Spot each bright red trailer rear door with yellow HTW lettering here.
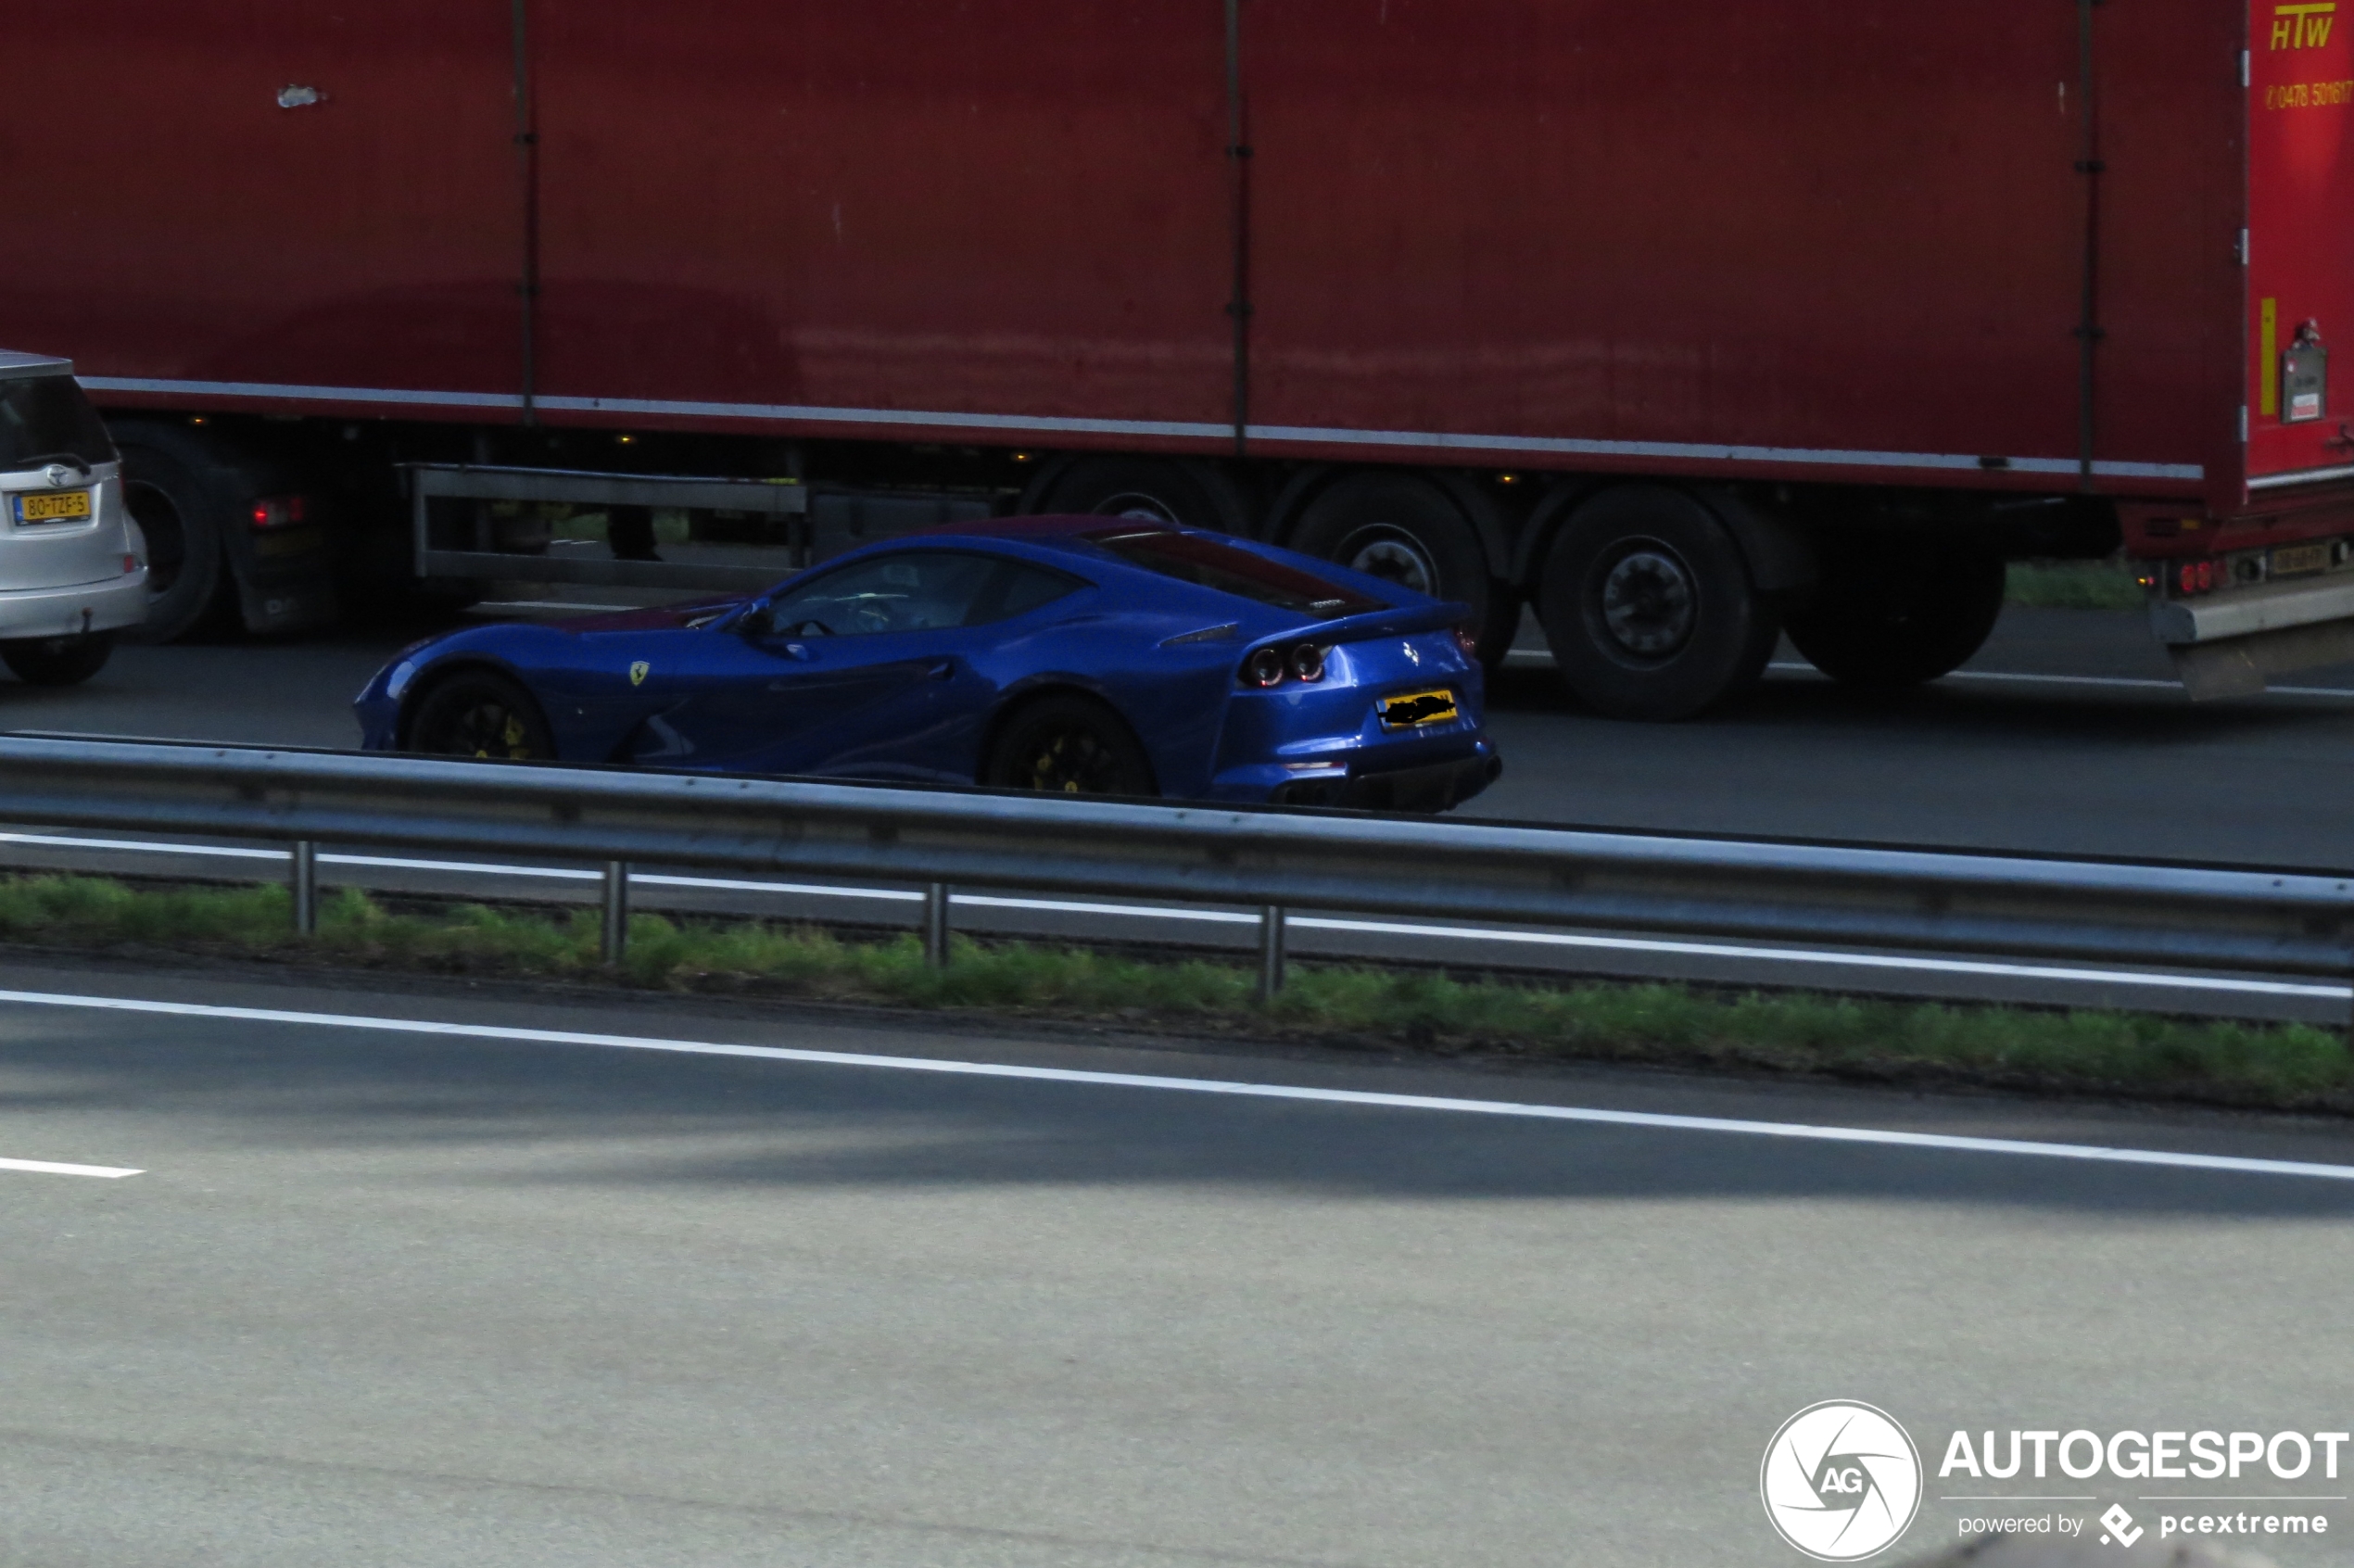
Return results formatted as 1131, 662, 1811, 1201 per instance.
2248, 0, 2354, 492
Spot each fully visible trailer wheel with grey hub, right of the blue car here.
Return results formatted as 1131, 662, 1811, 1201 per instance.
1538, 485, 1779, 720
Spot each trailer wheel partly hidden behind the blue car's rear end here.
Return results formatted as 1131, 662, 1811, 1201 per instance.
1290, 471, 1521, 664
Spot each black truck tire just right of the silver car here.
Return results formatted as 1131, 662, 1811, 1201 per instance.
115, 424, 243, 643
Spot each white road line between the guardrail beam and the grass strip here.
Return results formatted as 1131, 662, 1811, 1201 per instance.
0, 833, 2354, 1001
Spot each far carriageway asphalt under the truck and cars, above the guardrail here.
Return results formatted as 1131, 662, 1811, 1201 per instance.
0, 600, 2354, 868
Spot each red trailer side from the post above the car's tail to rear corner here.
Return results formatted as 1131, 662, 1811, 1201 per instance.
1246, 0, 2236, 489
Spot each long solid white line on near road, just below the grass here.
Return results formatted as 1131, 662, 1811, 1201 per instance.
0, 992, 2354, 1182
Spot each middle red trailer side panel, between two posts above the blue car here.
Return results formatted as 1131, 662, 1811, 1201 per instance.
535, 0, 1231, 445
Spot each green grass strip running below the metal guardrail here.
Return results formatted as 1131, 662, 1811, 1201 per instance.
0, 876, 2354, 1111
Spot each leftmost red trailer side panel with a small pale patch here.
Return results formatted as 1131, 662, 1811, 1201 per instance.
0, 0, 523, 417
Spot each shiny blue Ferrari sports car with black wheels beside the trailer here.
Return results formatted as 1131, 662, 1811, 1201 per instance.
356, 518, 1502, 810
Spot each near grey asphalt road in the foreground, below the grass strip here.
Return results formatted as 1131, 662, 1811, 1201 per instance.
0, 967, 2354, 1568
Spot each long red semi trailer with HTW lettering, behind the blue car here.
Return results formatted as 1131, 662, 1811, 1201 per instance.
0, 0, 2354, 718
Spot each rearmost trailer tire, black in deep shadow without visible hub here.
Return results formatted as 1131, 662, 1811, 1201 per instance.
1784, 541, 2006, 692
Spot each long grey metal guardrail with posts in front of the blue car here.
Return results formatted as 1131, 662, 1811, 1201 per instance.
0, 737, 2354, 1007
